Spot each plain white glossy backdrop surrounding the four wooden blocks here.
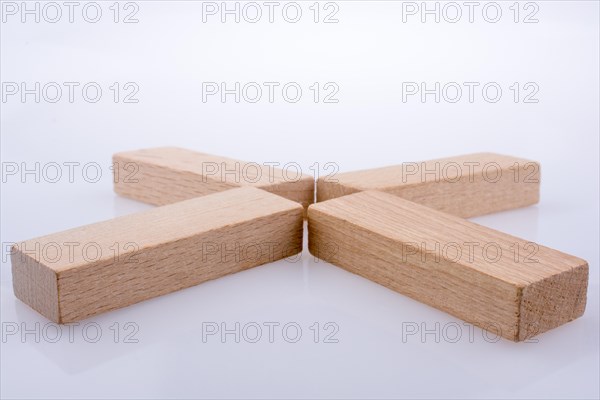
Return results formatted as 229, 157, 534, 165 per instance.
0, 1, 600, 398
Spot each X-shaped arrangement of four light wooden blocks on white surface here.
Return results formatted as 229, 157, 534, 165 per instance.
11, 147, 588, 341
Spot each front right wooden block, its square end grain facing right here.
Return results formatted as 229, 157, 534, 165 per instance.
308, 191, 588, 341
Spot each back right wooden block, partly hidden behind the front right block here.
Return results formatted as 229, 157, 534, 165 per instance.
317, 153, 540, 218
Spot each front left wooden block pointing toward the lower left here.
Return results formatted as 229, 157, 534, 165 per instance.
11, 188, 303, 323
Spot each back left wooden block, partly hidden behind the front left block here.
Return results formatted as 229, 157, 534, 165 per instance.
113, 147, 315, 208
